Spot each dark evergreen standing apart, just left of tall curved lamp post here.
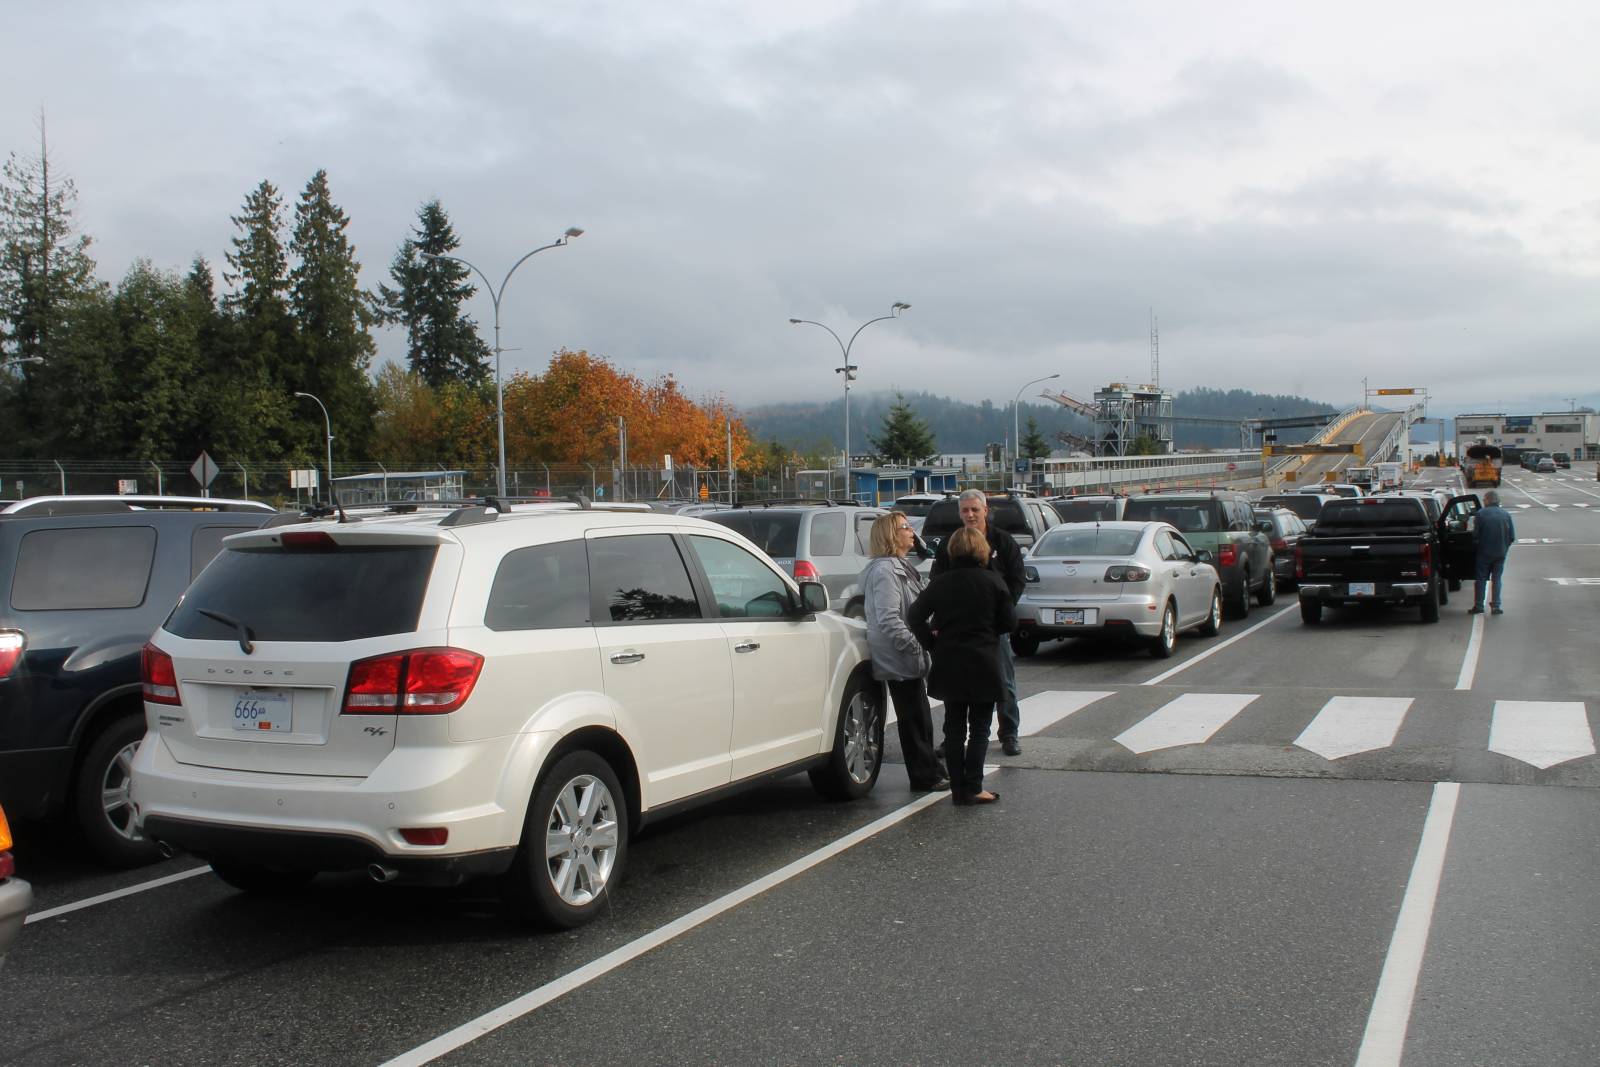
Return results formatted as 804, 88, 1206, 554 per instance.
378, 200, 493, 389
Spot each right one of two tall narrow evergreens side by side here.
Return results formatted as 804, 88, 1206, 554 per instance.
285, 170, 376, 456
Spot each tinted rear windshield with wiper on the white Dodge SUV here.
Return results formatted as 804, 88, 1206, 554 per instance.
166, 544, 437, 641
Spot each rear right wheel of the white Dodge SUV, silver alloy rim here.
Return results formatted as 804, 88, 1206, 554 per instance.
504, 749, 629, 929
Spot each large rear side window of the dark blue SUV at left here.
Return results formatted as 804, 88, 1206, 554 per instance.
11, 526, 155, 611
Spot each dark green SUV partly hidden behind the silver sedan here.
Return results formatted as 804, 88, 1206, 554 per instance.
1122, 490, 1278, 619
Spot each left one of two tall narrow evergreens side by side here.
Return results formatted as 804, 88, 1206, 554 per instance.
214, 181, 296, 459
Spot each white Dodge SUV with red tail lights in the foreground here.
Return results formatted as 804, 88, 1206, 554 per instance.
133, 502, 885, 926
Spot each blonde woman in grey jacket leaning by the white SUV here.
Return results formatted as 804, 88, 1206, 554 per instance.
861, 512, 950, 792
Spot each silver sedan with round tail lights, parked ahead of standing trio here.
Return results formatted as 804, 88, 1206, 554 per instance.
1011, 522, 1222, 657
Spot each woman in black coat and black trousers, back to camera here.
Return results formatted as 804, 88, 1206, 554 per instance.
906, 526, 1016, 805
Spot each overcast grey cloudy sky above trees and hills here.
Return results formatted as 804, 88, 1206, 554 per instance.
0, 0, 1600, 411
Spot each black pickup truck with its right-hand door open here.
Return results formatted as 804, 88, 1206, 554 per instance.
1294, 496, 1480, 624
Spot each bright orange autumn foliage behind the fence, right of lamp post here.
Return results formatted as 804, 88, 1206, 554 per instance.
506, 349, 758, 470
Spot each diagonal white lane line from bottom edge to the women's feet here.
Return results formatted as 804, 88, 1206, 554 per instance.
384, 793, 949, 1067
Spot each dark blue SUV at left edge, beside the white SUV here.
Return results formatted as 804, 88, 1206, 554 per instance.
0, 498, 275, 867
